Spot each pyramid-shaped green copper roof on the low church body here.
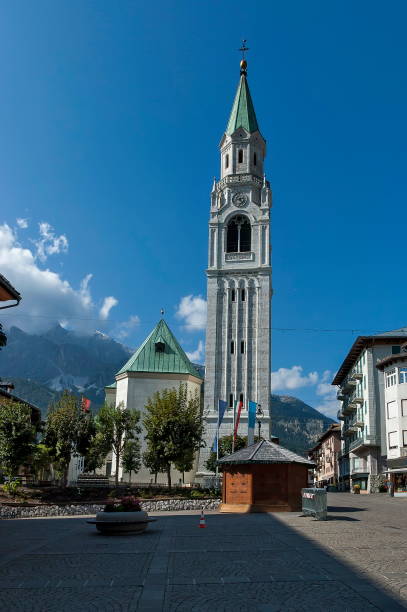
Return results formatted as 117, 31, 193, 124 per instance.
117, 319, 202, 378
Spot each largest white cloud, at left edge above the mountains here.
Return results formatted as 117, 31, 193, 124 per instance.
0, 223, 118, 332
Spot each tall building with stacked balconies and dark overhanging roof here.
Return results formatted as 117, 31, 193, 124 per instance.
332, 328, 407, 493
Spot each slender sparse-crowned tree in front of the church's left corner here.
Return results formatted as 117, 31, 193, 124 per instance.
96, 402, 141, 486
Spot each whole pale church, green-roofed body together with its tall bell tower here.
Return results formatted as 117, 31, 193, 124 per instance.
106, 59, 272, 484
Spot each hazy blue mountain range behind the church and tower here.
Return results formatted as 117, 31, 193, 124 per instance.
0, 325, 334, 454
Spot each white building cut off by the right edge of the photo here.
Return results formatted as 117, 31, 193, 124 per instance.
376, 352, 407, 496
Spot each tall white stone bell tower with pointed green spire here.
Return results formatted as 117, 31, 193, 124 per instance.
197, 60, 272, 476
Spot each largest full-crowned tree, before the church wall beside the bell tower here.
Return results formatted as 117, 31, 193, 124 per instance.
143, 384, 205, 489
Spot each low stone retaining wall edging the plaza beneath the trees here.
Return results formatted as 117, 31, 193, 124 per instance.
0, 499, 220, 519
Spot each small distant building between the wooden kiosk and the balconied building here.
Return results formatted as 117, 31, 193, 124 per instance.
309, 424, 341, 487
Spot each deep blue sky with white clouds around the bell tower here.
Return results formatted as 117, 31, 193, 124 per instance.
0, 0, 407, 414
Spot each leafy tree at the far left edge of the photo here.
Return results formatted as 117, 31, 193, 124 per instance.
0, 398, 37, 476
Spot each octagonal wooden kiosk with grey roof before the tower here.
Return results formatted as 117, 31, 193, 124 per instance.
218, 440, 315, 512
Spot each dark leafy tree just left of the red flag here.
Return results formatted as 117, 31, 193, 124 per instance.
43, 391, 96, 486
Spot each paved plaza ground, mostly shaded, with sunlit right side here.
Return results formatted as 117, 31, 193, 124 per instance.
0, 493, 407, 612
